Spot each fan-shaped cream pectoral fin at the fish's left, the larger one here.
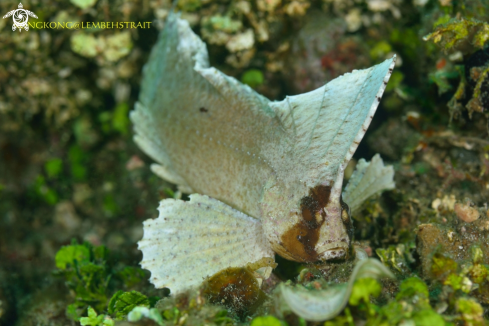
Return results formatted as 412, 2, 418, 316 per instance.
139, 194, 274, 294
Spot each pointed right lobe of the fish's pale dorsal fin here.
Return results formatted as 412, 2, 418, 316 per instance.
270, 56, 395, 195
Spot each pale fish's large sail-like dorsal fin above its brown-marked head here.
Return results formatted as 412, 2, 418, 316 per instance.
131, 14, 394, 217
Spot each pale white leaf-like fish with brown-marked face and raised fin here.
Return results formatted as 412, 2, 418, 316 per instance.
131, 14, 395, 293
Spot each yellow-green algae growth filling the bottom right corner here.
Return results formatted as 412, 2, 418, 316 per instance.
325, 246, 489, 326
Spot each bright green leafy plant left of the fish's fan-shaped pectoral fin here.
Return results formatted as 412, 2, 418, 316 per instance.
55, 241, 153, 326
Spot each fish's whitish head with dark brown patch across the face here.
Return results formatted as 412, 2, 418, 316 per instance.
262, 185, 353, 262
